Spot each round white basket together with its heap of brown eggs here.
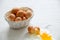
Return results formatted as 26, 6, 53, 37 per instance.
5, 7, 33, 29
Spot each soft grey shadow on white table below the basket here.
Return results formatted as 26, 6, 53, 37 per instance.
7, 28, 26, 40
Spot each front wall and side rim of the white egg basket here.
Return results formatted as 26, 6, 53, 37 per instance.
5, 11, 33, 29
